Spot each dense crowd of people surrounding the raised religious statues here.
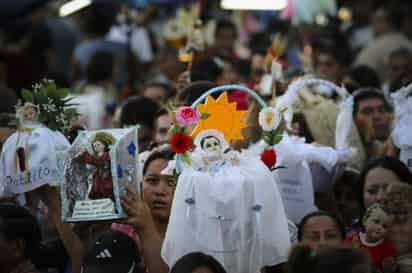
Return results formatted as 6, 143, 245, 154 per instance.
0, 0, 412, 273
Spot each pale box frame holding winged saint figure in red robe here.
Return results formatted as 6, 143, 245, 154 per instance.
58, 128, 140, 222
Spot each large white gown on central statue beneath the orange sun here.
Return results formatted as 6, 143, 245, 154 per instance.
162, 151, 290, 273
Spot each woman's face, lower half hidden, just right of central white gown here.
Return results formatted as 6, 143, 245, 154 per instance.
301, 215, 343, 251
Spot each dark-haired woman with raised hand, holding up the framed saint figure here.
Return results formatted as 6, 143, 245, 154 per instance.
122, 147, 176, 273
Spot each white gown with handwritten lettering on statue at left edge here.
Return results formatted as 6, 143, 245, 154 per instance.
0, 123, 70, 197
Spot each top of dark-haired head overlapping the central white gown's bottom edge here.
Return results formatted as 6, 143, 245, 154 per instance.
170, 252, 226, 273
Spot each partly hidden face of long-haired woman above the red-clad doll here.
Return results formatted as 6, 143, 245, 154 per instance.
363, 167, 400, 208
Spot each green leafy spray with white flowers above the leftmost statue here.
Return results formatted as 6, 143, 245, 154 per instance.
16, 79, 79, 133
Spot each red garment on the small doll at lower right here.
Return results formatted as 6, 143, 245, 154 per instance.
346, 233, 396, 269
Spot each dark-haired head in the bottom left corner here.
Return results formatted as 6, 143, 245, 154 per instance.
0, 204, 41, 273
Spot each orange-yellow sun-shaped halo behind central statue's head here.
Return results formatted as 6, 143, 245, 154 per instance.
192, 92, 247, 143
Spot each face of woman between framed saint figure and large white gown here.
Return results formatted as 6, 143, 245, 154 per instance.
142, 159, 176, 221
